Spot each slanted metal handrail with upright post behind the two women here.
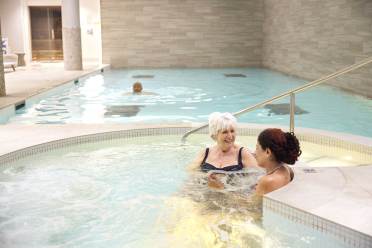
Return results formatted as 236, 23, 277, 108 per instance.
182, 57, 372, 142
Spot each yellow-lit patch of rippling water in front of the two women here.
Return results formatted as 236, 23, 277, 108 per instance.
160, 170, 274, 248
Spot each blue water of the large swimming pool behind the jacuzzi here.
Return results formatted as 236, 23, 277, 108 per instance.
5, 68, 372, 137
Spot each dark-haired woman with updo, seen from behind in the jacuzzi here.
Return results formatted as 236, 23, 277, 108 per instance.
256, 128, 301, 195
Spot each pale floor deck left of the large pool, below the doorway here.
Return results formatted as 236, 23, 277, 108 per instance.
0, 62, 108, 110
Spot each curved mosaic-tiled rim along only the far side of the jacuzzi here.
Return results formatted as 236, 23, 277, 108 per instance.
0, 125, 372, 168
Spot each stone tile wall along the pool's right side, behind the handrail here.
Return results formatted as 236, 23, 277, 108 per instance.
262, 0, 372, 97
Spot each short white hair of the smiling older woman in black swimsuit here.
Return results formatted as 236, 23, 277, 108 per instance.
209, 112, 237, 139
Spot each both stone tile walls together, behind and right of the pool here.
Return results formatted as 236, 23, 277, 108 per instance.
101, 0, 372, 97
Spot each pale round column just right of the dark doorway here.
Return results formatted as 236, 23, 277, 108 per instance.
62, 0, 83, 70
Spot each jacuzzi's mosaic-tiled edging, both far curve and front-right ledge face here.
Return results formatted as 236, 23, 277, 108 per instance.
0, 125, 372, 247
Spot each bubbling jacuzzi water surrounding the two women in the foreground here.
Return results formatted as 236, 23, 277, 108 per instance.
0, 135, 364, 248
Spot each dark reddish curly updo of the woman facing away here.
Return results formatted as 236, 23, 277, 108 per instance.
258, 128, 301, 164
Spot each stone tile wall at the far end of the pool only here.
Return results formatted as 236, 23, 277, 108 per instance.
101, 0, 264, 68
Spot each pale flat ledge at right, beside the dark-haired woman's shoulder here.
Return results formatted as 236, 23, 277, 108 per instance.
266, 165, 372, 237
